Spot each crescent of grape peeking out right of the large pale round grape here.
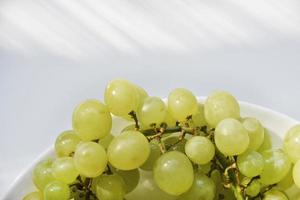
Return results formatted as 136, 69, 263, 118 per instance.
242, 117, 264, 150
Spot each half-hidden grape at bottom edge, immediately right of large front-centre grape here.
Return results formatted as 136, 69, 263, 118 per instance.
178, 173, 216, 200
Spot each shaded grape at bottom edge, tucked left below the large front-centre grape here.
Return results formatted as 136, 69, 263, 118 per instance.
125, 171, 177, 200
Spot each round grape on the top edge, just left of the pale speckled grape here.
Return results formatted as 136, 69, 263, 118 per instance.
168, 88, 198, 121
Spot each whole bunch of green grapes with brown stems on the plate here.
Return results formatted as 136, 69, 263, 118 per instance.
23, 80, 300, 200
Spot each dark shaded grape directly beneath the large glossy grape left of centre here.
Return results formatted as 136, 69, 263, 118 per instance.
112, 168, 140, 194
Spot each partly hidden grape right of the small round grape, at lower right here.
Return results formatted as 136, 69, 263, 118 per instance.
260, 149, 291, 185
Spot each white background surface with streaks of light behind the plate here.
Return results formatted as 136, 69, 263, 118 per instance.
0, 0, 300, 197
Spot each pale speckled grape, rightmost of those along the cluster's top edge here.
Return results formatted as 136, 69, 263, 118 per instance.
204, 91, 240, 127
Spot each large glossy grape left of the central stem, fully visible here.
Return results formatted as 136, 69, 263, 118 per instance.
107, 131, 150, 170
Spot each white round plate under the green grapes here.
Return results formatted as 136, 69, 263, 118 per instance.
4, 102, 300, 200
